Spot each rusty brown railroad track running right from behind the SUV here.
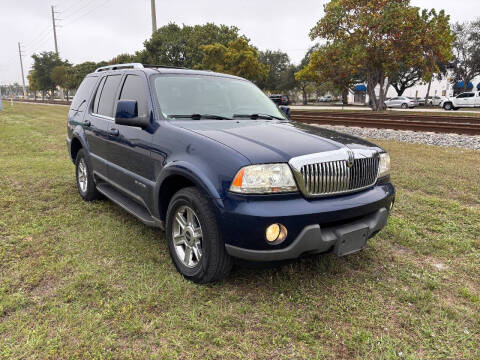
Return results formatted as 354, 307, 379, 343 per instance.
291, 111, 480, 135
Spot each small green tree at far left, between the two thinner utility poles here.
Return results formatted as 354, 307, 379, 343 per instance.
30, 51, 68, 99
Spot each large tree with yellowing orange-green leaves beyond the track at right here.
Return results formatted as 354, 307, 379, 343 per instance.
310, 0, 453, 110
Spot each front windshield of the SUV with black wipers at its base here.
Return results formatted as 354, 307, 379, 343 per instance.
154, 75, 285, 120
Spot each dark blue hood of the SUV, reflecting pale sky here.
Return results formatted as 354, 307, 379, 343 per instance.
171, 120, 382, 163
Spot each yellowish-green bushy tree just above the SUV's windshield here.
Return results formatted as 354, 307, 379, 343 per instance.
198, 38, 269, 83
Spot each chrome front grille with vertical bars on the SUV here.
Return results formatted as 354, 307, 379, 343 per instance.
290, 150, 379, 197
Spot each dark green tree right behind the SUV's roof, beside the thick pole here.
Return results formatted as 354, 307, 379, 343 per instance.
141, 23, 242, 68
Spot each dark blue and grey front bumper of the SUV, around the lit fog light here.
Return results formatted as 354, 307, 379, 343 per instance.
219, 183, 395, 261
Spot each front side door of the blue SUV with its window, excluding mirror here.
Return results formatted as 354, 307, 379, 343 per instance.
108, 72, 154, 207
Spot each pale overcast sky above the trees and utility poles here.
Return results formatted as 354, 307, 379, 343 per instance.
0, 0, 480, 84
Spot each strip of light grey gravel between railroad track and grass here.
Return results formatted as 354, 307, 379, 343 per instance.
311, 124, 480, 150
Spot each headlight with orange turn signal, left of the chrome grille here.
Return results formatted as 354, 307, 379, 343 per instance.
230, 164, 297, 194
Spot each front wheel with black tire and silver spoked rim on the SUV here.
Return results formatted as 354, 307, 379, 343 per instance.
166, 187, 233, 284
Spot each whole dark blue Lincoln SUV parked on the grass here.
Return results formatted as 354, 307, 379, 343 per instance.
67, 64, 395, 283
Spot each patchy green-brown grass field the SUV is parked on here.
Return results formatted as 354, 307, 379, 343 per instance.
0, 103, 480, 359
